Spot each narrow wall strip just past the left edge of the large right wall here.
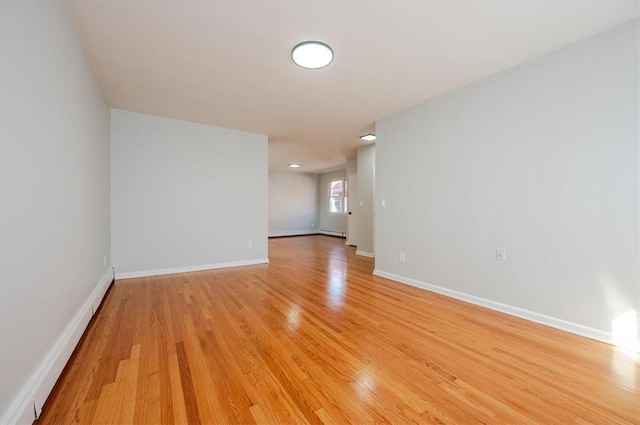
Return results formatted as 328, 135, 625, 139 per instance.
353, 144, 376, 257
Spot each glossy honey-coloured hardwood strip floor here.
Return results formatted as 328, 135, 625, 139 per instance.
37, 236, 640, 425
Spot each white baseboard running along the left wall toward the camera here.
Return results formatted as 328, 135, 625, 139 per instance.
0, 268, 114, 425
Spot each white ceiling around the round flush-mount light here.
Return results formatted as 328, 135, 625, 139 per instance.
63, 0, 639, 172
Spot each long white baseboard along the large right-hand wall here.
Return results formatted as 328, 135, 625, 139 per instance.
373, 269, 613, 345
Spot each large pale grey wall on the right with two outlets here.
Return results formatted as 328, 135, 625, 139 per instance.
376, 20, 640, 346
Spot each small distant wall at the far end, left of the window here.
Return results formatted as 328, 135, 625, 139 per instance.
269, 171, 318, 236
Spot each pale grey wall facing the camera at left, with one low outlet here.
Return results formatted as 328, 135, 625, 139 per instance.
111, 109, 268, 278
